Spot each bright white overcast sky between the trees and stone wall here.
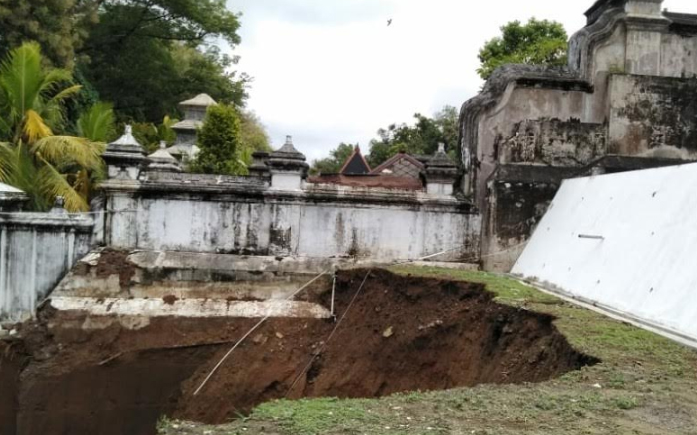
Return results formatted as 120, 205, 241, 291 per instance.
228, 0, 697, 164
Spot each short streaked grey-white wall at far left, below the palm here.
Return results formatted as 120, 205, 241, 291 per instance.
0, 212, 93, 320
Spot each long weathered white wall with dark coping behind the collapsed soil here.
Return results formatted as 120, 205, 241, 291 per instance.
104, 174, 480, 261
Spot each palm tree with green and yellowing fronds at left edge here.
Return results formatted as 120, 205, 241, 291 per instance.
0, 42, 113, 212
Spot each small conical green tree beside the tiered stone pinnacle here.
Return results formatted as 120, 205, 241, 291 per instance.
190, 104, 246, 175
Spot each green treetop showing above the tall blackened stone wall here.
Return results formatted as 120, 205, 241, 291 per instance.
477, 18, 568, 80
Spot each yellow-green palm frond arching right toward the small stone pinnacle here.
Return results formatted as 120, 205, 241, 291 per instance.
32, 136, 105, 170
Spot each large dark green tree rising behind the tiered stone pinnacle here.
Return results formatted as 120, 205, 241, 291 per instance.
79, 0, 248, 122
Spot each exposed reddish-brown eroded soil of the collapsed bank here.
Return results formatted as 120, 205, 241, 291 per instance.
0, 270, 596, 435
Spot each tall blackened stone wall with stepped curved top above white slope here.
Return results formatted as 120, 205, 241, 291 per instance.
460, 0, 697, 271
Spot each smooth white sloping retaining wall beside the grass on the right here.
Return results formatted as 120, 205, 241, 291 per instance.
513, 164, 697, 346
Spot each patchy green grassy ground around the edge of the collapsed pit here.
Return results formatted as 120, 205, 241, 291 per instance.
160, 267, 697, 435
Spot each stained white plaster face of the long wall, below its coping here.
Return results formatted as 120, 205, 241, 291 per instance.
107, 193, 480, 261
